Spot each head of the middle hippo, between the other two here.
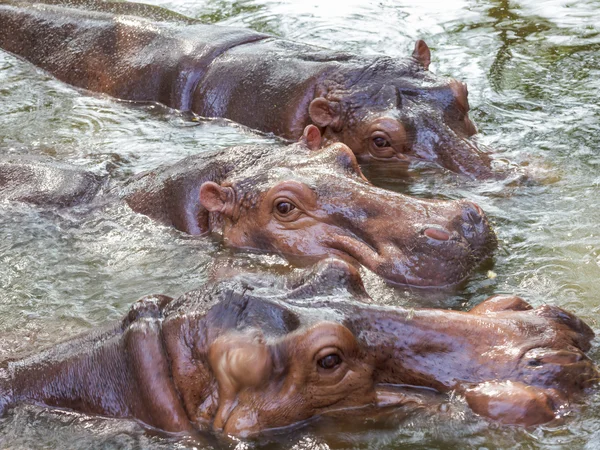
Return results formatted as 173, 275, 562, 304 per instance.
199, 125, 496, 287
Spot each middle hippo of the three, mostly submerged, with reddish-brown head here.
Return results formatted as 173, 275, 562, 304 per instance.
0, 125, 496, 287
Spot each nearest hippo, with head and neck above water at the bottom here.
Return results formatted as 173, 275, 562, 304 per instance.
0, 260, 598, 438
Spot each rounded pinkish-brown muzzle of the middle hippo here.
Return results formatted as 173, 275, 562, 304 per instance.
332, 192, 496, 287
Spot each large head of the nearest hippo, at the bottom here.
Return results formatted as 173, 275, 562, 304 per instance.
162, 261, 597, 437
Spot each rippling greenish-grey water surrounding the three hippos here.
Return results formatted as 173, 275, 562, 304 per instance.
0, 0, 600, 449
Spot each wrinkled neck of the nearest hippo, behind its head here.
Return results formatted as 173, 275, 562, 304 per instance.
0, 317, 191, 432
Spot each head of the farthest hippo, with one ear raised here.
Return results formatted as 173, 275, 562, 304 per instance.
309, 40, 494, 179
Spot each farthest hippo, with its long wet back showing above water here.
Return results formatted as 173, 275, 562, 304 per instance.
0, 0, 499, 179
